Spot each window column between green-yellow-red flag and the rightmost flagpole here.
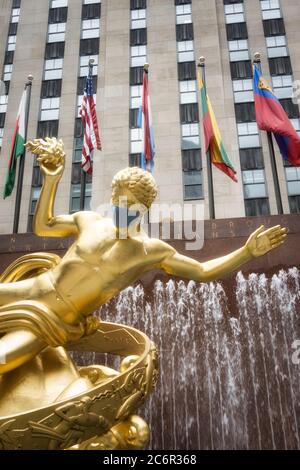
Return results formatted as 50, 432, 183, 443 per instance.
224, 0, 270, 216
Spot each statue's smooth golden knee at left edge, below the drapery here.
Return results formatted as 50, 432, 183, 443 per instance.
0, 330, 47, 375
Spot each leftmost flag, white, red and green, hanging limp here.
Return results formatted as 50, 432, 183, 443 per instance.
4, 90, 27, 199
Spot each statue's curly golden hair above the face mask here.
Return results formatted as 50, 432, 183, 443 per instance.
112, 167, 157, 209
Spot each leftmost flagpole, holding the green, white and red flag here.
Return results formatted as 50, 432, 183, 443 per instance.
13, 75, 33, 233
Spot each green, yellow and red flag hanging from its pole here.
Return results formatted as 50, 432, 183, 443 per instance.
198, 71, 237, 182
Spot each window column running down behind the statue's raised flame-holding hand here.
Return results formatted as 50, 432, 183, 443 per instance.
28, 0, 68, 232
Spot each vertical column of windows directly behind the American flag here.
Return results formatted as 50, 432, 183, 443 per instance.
70, 0, 101, 213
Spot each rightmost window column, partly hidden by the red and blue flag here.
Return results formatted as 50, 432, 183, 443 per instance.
260, 0, 300, 213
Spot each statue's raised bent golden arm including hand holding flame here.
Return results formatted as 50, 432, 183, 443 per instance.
26, 138, 78, 237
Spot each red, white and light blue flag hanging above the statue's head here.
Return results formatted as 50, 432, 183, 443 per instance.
138, 68, 155, 172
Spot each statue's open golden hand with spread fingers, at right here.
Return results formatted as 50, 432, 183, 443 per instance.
246, 225, 287, 258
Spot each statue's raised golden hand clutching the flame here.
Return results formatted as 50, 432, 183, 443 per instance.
25, 137, 66, 177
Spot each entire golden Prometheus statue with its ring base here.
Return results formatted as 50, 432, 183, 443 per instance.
0, 138, 286, 449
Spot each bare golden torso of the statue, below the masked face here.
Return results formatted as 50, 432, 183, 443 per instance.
31, 214, 173, 322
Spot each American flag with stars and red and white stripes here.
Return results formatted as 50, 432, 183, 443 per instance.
79, 72, 102, 173
